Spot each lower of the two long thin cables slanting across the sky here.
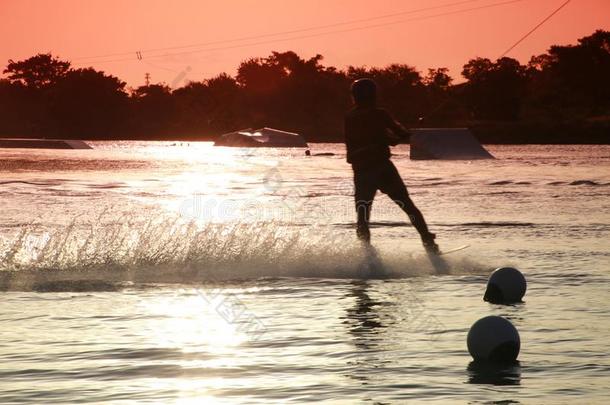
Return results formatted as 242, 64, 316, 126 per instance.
75, 0, 526, 63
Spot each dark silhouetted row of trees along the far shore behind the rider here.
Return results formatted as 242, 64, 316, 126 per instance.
0, 30, 610, 143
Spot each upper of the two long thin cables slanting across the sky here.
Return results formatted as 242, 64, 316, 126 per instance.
72, 0, 490, 61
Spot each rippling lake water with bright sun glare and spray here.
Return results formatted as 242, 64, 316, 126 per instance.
0, 142, 610, 404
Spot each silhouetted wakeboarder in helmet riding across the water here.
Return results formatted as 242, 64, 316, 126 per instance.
345, 79, 439, 253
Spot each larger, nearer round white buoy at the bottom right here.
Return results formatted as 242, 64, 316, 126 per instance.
466, 315, 521, 363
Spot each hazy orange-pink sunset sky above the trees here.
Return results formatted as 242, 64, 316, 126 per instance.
0, 0, 610, 87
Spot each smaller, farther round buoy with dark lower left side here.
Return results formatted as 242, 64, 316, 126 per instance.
483, 267, 527, 304
